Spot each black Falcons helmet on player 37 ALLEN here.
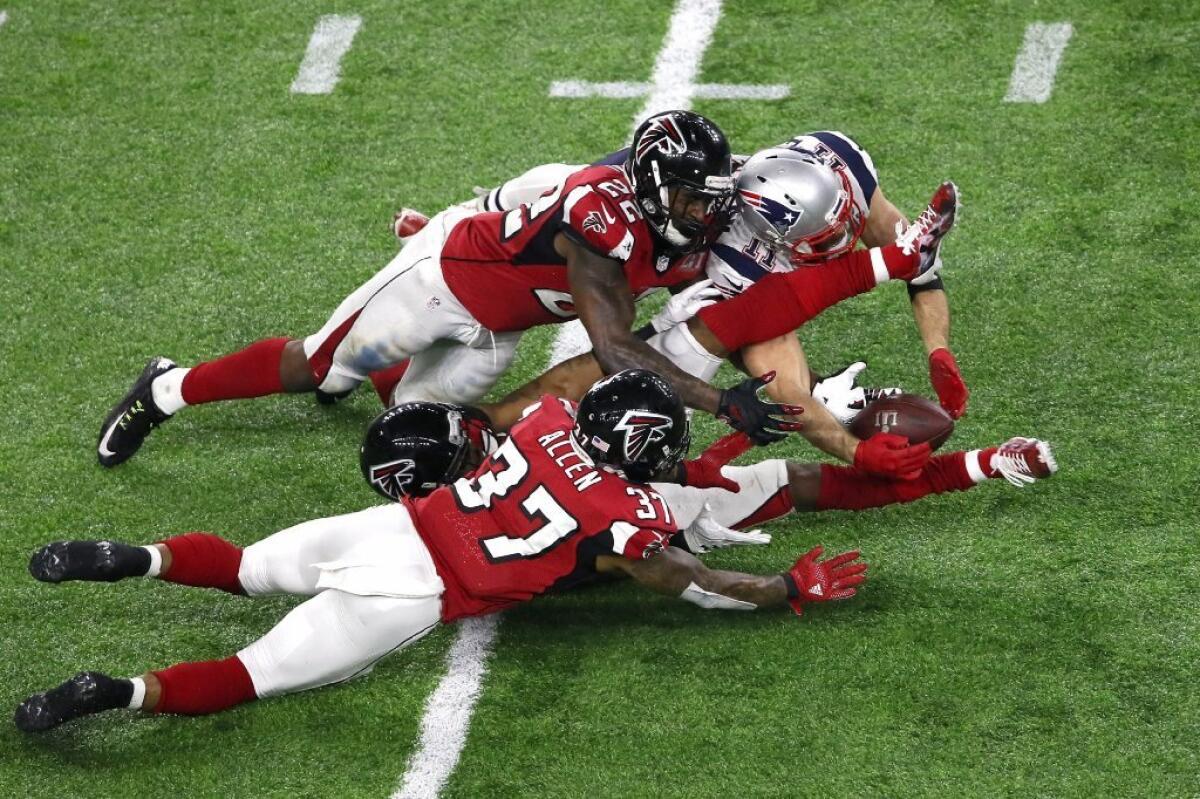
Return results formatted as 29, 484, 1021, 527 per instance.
571, 370, 691, 482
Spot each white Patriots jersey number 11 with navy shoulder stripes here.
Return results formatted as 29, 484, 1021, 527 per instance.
706, 131, 878, 296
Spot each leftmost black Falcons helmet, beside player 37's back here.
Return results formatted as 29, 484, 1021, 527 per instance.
359, 402, 496, 501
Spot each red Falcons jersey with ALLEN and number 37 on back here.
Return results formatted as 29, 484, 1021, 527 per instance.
406, 396, 677, 621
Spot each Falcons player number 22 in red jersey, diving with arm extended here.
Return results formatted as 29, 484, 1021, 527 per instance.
97, 112, 799, 467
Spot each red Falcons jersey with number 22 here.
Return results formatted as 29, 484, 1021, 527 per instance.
442, 166, 700, 332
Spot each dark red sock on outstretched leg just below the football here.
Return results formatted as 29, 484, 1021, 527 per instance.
817, 452, 976, 510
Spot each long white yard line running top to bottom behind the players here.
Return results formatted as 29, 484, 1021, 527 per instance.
392, 0, 729, 799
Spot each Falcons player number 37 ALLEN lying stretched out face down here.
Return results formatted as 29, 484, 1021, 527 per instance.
21, 370, 866, 732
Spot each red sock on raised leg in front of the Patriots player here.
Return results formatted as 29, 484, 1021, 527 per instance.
697, 245, 917, 353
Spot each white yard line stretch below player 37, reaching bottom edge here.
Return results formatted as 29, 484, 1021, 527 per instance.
391, 615, 499, 799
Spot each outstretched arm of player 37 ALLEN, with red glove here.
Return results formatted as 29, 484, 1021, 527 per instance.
596, 537, 866, 614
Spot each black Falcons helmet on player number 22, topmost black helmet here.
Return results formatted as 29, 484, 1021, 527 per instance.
625, 110, 733, 253
